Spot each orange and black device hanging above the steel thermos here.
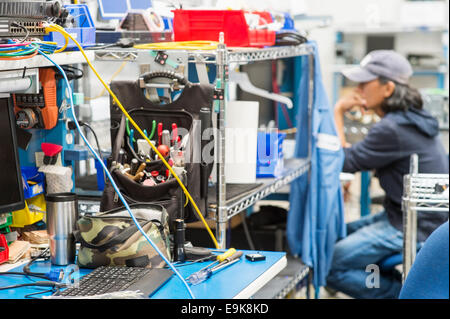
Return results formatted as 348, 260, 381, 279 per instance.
13, 68, 58, 130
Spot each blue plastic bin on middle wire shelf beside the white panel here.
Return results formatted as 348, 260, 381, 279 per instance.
256, 131, 286, 178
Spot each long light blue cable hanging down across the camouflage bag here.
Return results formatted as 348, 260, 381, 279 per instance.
38, 50, 195, 299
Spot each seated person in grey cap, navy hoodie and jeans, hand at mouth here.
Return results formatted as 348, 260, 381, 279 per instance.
327, 50, 448, 298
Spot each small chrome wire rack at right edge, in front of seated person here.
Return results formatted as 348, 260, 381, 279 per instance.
402, 154, 449, 280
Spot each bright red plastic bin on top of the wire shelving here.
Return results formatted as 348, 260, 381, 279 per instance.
173, 9, 276, 47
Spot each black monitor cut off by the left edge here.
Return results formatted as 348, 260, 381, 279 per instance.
0, 93, 25, 213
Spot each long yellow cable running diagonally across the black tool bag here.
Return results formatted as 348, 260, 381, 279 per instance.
46, 25, 220, 249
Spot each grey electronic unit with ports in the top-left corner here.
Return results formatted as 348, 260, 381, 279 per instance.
0, 0, 68, 38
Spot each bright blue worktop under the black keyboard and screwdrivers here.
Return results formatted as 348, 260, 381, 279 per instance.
0, 250, 287, 299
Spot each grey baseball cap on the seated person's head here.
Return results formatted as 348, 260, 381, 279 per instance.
342, 50, 413, 84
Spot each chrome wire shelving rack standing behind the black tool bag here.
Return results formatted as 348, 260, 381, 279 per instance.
94, 43, 314, 249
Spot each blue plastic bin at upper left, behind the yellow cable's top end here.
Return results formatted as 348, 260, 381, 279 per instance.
44, 4, 96, 50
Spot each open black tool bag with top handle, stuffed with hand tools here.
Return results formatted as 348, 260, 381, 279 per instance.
100, 74, 214, 225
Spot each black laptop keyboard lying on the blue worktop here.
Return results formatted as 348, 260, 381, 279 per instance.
55, 266, 173, 297
